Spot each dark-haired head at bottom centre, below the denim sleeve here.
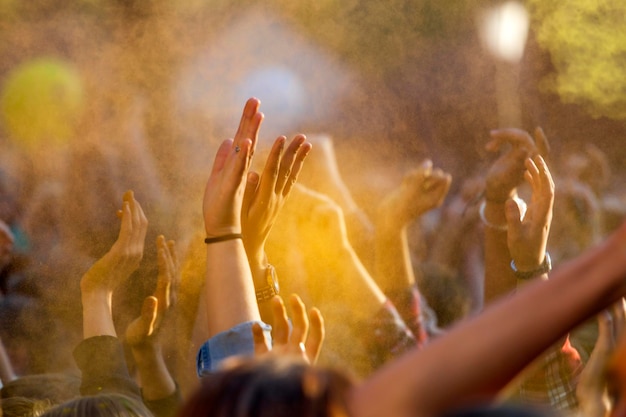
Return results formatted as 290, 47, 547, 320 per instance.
178, 358, 352, 417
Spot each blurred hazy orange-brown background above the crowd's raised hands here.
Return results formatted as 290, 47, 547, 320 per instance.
0, 0, 626, 214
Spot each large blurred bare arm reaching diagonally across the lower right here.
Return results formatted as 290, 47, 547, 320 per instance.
354, 227, 626, 416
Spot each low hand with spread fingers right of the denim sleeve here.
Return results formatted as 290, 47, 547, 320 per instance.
252, 294, 325, 364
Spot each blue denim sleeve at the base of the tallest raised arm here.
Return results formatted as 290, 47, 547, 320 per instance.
196, 321, 272, 377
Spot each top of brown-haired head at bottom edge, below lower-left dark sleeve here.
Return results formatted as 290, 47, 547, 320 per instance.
41, 394, 153, 417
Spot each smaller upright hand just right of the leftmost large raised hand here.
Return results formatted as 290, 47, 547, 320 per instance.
126, 235, 180, 349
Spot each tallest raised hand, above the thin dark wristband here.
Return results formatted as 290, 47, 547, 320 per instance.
202, 98, 263, 237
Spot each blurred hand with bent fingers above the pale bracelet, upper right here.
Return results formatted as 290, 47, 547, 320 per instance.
485, 127, 549, 203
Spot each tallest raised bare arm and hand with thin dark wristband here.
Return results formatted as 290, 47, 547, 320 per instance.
202, 99, 263, 336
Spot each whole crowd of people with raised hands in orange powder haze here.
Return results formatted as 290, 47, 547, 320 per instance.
0, 98, 626, 417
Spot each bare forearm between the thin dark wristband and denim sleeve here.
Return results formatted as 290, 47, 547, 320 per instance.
204, 239, 261, 336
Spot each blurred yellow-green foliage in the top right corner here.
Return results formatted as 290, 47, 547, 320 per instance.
528, 0, 626, 119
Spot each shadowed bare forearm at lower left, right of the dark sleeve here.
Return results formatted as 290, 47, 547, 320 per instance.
131, 343, 176, 401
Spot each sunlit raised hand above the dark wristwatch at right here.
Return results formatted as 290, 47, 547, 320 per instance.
505, 155, 554, 271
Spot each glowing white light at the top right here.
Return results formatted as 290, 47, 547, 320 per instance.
482, 1, 529, 63
